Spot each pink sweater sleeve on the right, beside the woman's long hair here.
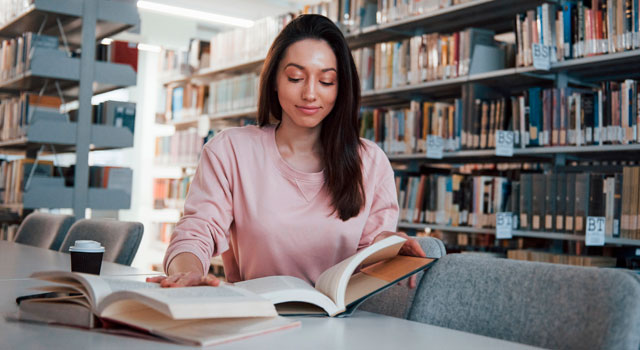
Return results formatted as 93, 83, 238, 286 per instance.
358, 146, 399, 250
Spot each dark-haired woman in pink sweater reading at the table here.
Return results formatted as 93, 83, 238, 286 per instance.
148, 15, 424, 287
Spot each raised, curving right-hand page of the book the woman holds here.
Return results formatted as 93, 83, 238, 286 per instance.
316, 236, 406, 310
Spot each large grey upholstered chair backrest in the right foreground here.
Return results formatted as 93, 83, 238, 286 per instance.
409, 254, 640, 349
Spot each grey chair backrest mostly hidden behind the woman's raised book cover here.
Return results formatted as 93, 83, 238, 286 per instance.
358, 237, 447, 318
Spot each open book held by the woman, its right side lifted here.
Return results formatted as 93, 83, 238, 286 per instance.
235, 236, 434, 316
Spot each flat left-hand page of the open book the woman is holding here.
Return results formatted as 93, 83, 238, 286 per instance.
235, 276, 338, 315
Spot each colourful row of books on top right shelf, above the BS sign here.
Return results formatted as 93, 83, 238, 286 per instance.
515, 0, 640, 66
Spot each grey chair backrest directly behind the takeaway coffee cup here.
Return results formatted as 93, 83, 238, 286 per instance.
60, 219, 144, 265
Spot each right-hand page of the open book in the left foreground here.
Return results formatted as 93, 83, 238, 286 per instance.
98, 285, 277, 320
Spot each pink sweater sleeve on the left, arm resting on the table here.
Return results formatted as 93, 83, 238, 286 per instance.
163, 133, 234, 273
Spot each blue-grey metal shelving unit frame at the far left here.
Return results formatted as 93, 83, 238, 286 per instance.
0, 0, 140, 219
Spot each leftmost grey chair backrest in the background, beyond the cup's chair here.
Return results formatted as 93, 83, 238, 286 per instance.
15, 212, 75, 250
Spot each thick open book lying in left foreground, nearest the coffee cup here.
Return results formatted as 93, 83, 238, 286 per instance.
19, 271, 300, 346
